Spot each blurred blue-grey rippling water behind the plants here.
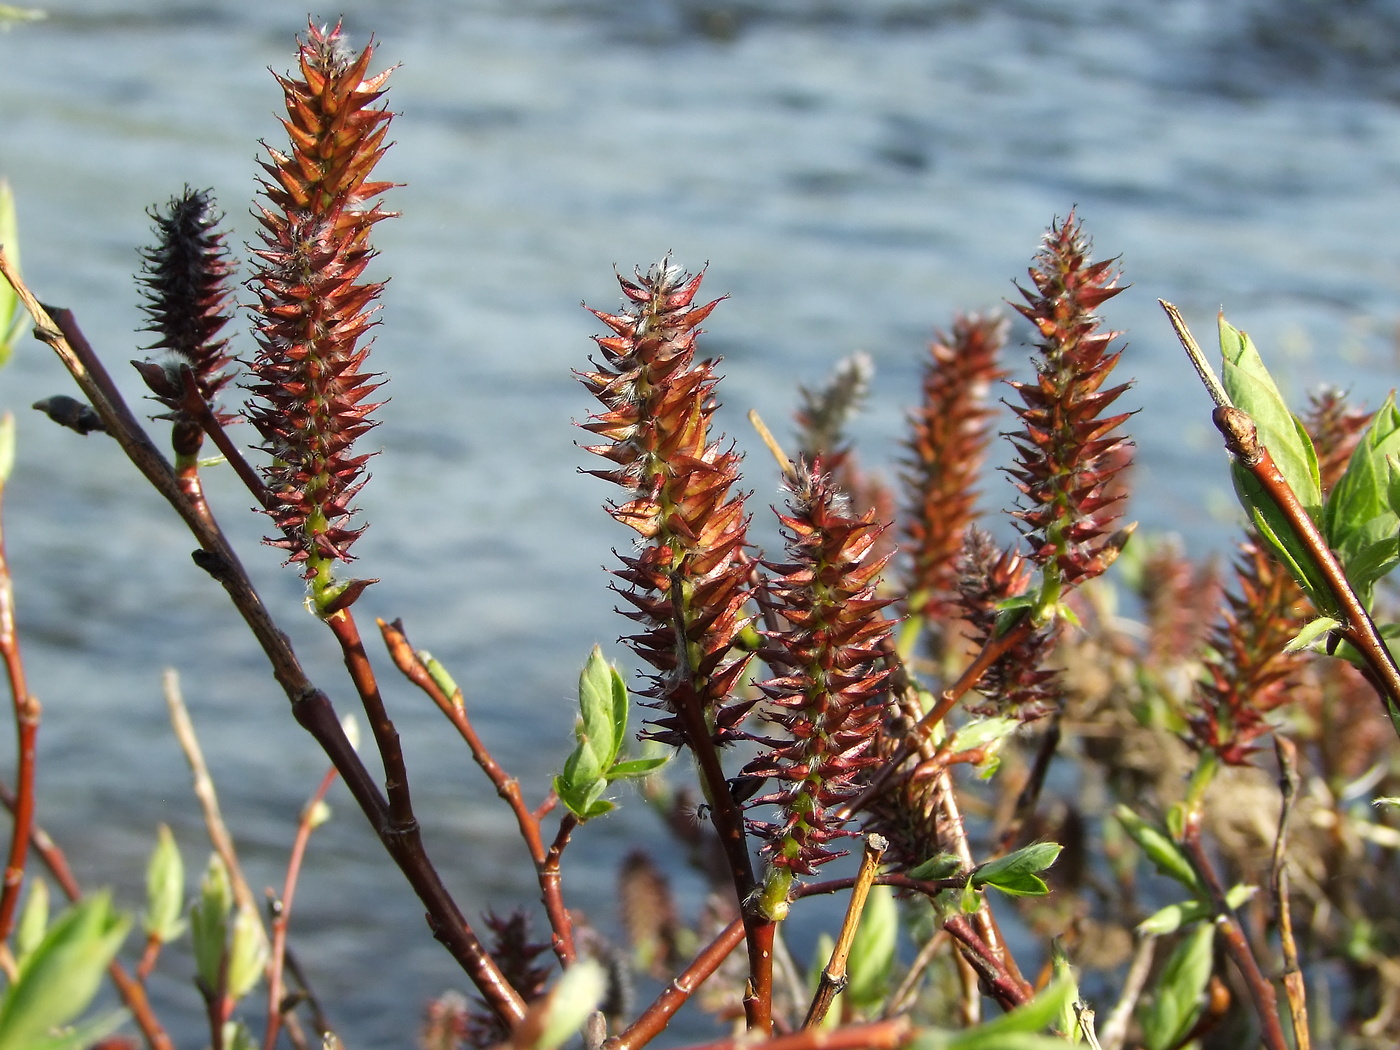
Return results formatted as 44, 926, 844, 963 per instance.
0, 0, 1400, 1047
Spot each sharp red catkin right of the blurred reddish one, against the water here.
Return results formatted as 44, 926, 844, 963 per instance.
1008, 213, 1131, 616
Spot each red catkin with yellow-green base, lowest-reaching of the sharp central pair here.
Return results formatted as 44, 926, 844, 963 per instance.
748, 461, 892, 917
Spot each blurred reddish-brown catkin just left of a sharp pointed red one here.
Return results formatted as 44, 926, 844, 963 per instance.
902, 315, 1008, 620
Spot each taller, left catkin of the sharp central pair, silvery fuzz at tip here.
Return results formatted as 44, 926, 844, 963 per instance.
578, 258, 753, 748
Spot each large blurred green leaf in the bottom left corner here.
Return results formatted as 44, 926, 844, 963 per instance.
0, 890, 132, 1050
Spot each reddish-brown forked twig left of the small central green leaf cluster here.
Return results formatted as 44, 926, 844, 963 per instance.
379, 620, 577, 966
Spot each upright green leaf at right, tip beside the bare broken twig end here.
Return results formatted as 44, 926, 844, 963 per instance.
1219, 314, 1322, 517
